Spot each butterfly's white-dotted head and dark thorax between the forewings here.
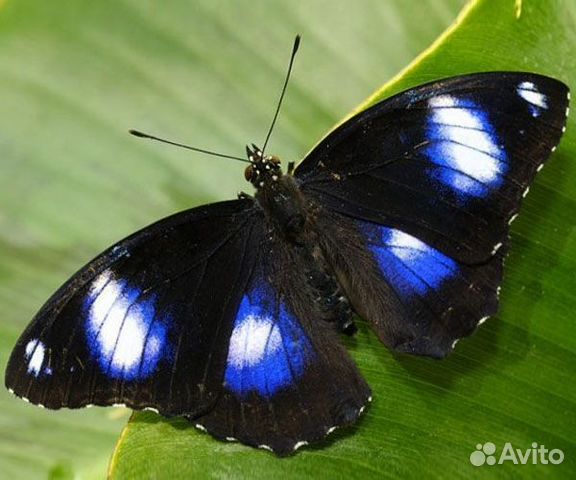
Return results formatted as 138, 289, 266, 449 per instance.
244, 145, 307, 243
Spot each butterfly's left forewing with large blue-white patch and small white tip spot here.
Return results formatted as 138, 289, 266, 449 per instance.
5, 200, 255, 415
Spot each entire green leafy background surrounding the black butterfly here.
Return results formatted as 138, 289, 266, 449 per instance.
0, 0, 576, 479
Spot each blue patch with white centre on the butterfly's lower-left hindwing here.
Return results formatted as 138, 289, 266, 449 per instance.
224, 279, 313, 398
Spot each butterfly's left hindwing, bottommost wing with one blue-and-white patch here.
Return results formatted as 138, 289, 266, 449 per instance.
196, 234, 370, 456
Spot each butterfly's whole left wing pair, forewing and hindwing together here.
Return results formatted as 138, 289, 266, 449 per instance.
6, 200, 370, 455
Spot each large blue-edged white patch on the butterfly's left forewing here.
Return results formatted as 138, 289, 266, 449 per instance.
84, 271, 169, 380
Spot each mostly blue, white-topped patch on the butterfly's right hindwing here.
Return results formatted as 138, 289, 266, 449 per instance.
358, 222, 458, 299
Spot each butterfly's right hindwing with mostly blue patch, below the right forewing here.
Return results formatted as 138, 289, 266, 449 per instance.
318, 212, 507, 358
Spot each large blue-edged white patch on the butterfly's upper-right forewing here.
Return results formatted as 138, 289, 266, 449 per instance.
423, 94, 508, 198
